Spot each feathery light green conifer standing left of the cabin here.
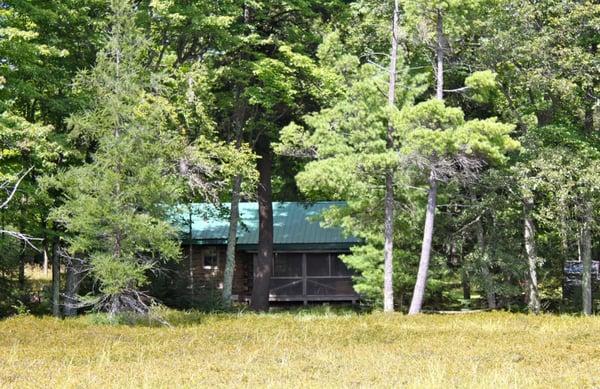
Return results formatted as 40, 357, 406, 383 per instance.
52, 1, 190, 313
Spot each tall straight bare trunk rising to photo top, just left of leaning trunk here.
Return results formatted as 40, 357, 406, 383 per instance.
383, 0, 398, 312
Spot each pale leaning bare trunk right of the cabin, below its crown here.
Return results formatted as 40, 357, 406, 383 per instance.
408, 174, 438, 315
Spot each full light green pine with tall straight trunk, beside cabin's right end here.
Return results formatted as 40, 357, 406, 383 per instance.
277, 2, 423, 311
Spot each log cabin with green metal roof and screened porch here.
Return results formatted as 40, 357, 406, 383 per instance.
179, 202, 359, 304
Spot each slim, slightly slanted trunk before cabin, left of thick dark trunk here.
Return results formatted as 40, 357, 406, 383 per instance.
223, 176, 242, 307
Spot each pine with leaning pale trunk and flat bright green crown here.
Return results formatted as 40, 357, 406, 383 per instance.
399, 98, 518, 314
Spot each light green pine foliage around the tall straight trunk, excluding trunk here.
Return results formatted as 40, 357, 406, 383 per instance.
276, 4, 432, 305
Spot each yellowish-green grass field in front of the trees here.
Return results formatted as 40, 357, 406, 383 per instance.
0, 311, 600, 388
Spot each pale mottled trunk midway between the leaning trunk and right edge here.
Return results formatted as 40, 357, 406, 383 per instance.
523, 197, 540, 315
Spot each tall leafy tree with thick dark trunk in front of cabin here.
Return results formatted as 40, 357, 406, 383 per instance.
144, 0, 343, 309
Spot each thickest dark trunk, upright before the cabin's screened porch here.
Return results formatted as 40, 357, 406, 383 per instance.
251, 135, 273, 311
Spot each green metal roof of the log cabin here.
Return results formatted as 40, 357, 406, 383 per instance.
177, 201, 358, 249
